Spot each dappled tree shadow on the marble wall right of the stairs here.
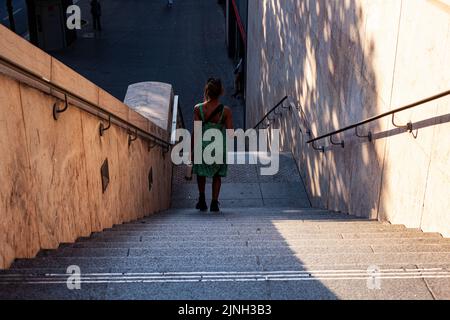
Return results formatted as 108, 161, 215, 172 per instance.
255, 0, 390, 218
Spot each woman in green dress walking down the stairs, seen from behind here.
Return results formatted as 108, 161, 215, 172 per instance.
192, 78, 233, 212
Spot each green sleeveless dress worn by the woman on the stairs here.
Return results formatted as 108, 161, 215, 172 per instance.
192, 104, 228, 178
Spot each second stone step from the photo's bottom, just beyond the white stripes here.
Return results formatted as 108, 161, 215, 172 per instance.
12, 252, 450, 272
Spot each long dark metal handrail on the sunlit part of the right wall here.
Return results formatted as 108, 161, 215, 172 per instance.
306, 90, 450, 146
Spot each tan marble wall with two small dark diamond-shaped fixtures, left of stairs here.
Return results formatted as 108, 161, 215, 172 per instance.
0, 26, 172, 269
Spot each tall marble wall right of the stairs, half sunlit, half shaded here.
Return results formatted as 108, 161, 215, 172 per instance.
247, 0, 450, 236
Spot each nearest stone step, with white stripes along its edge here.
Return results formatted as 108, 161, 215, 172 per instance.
0, 272, 448, 301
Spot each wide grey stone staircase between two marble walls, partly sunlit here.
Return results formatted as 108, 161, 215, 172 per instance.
0, 155, 450, 299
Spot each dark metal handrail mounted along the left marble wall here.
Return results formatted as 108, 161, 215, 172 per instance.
0, 57, 172, 149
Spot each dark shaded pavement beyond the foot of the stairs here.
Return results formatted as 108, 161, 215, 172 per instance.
52, 0, 243, 128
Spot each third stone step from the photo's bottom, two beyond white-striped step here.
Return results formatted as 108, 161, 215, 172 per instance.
40, 245, 450, 257
